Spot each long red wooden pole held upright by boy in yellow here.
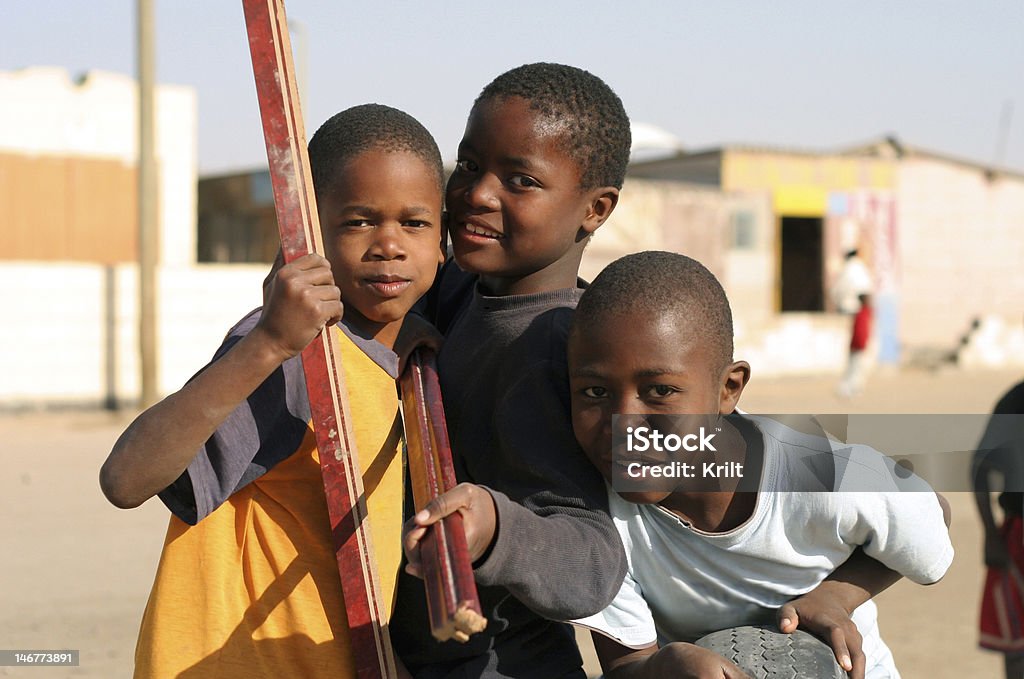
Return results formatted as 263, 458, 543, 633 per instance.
242, 0, 398, 679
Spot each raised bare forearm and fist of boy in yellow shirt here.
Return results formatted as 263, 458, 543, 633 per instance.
99, 255, 342, 508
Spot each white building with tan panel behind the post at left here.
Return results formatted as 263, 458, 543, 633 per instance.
0, 68, 265, 409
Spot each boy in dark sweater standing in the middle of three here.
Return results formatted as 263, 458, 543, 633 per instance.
391, 63, 630, 678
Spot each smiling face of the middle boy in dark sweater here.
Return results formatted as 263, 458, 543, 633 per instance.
446, 97, 617, 294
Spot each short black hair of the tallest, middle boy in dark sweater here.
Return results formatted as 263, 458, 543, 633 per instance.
473, 62, 632, 189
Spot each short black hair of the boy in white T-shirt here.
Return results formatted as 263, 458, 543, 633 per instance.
572, 251, 732, 374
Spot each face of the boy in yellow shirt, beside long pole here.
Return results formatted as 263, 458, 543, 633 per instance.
316, 150, 444, 346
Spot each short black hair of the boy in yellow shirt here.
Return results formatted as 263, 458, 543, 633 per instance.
309, 103, 444, 194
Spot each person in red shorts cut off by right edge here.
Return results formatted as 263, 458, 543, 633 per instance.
973, 382, 1024, 679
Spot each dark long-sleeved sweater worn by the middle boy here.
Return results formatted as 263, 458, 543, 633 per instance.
391, 262, 626, 678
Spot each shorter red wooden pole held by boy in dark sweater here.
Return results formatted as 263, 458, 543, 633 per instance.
399, 347, 487, 641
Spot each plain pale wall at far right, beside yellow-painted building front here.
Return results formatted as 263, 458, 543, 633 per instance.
897, 158, 1024, 356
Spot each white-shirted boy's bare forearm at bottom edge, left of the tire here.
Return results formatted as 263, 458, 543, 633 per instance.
591, 632, 750, 679
